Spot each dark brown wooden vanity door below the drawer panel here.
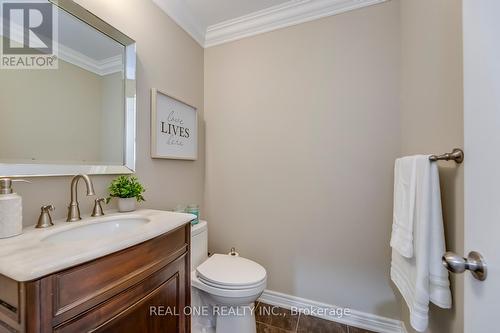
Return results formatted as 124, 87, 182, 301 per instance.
54, 253, 190, 333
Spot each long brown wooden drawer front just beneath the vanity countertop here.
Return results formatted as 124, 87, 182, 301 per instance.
52, 227, 189, 316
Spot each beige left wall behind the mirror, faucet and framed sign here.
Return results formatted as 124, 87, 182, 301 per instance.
16, 0, 205, 225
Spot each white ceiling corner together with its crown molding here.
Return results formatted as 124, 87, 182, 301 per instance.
153, 0, 390, 47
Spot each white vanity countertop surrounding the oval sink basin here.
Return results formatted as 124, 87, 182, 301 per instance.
0, 210, 195, 282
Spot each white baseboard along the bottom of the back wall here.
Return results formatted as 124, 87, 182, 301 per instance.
259, 290, 406, 333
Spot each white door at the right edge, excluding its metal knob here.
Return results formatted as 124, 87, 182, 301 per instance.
463, 0, 500, 333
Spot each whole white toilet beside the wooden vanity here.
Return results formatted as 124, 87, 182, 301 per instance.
191, 221, 267, 333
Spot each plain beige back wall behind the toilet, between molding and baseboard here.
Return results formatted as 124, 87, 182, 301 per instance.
205, 1, 400, 318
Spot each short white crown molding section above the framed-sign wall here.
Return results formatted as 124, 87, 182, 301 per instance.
153, 0, 206, 47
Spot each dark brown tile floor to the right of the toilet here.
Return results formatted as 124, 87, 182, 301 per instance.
255, 303, 374, 333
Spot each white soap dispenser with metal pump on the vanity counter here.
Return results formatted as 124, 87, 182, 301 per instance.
0, 178, 28, 238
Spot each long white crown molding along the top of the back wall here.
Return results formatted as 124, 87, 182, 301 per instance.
204, 0, 388, 47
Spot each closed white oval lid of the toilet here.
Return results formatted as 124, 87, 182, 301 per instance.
196, 254, 266, 289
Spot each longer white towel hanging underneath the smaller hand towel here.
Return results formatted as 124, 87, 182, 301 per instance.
391, 157, 451, 332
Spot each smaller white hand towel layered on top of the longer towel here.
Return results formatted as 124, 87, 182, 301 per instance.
391, 156, 418, 258
